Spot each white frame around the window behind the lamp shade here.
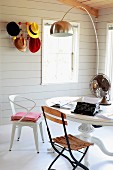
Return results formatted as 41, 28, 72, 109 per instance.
41, 20, 80, 85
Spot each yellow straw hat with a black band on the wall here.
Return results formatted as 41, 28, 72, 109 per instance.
27, 22, 40, 38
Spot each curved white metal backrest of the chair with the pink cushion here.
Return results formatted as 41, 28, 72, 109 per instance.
9, 95, 36, 114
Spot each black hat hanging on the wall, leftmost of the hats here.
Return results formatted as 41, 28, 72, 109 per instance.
6, 21, 21, 36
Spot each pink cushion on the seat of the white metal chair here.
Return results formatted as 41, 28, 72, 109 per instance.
11, 112, 41, 122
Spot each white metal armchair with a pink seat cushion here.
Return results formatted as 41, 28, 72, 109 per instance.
9, 95, 44, 153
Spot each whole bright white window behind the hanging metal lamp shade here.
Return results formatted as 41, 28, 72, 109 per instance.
42, 20, 80, 84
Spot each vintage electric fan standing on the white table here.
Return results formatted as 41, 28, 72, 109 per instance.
90, 73, 111, 105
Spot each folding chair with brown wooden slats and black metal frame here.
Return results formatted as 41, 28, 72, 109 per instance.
42, 106, 93, 170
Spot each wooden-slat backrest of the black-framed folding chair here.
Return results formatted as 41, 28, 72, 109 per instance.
42, 106, 67, 143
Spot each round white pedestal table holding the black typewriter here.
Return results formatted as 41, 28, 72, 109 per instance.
46, 97, 113, 156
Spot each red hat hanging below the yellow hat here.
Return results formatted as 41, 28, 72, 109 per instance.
29, 37, 41, 53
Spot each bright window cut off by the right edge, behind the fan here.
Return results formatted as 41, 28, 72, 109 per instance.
105, 23, 113, 99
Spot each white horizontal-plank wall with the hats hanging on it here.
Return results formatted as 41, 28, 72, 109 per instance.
0, 0, 96, 124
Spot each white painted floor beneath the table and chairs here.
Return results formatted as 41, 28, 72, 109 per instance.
0, 122, 113, 170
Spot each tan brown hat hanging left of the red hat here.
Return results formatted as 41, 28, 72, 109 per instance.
14, 36, 27, 52
